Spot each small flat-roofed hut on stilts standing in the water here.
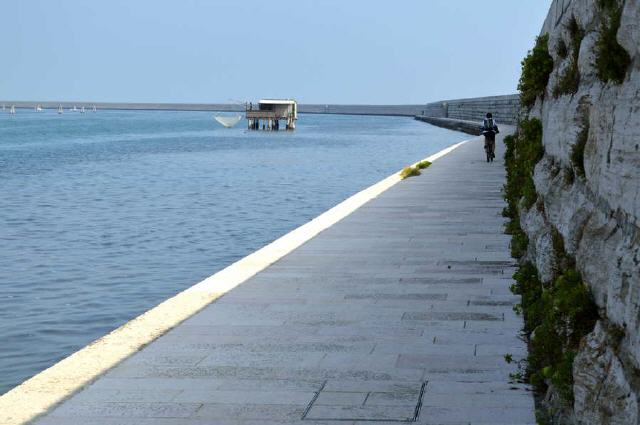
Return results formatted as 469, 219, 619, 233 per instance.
246, 99, 298, 130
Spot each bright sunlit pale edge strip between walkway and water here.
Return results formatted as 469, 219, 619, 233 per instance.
0, 140, 469, 425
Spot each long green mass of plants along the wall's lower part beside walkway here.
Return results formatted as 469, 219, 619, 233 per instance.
503, 119, 598, 406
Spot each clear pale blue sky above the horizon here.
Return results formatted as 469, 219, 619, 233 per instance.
0, 0, 551, 104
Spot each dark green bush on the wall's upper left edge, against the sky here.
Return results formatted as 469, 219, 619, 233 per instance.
518, 34, 553, 108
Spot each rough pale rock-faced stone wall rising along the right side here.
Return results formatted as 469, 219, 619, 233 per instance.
521, 0, 640, 425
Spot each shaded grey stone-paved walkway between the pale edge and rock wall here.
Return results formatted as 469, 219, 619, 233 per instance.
35, 131, 535, 425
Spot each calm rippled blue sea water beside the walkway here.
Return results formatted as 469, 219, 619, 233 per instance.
0, 110, 464, 393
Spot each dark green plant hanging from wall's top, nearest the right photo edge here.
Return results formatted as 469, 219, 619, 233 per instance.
596, 0, 631, 84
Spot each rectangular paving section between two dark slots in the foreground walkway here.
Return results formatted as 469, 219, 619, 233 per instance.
302, 381, 427, 423
